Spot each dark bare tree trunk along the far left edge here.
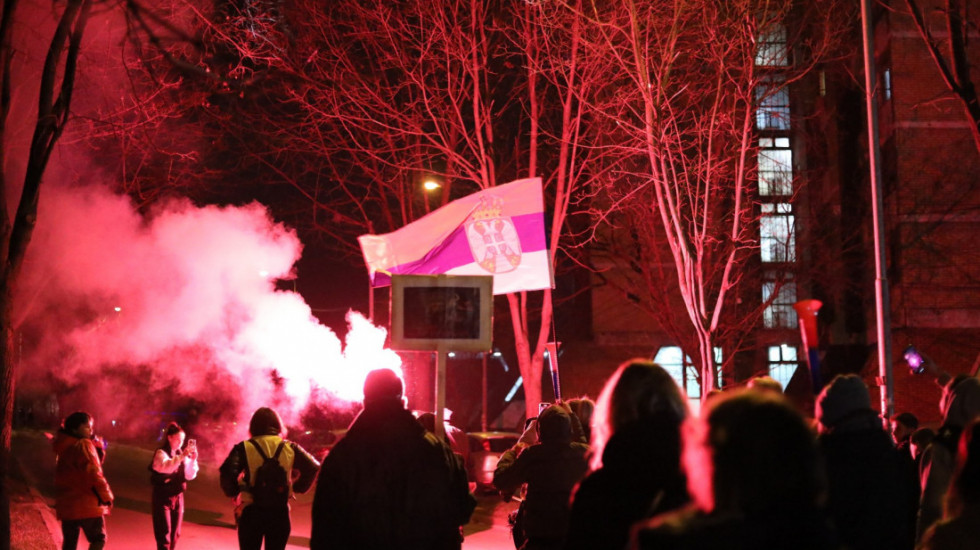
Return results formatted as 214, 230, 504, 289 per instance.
0, 0, 93, 548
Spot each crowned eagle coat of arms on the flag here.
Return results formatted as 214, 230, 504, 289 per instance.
465, 197, 521, 274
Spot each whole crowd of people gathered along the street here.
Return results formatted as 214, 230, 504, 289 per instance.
54, 359, 980, 550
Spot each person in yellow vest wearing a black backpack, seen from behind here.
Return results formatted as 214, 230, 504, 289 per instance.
219, 407, 320, 550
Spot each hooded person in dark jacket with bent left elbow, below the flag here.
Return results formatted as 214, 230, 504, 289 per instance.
493, 405, 589, 550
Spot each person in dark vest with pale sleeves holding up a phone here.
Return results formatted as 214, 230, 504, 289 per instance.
150, 422, 199, 550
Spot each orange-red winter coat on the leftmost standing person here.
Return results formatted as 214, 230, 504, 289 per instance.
54, 431, 113, 520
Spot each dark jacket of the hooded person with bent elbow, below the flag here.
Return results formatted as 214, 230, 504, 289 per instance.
493, 436, 589, 540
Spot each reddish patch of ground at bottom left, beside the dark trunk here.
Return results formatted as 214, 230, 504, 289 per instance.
7, 459, 61, 550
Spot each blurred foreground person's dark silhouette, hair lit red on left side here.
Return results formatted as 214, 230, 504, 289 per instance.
629, 389, 838, 550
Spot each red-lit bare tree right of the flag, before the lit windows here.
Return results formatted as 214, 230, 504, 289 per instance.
586, 0, 844, 395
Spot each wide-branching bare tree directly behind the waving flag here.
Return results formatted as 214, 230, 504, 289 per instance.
115, 0, 596, 415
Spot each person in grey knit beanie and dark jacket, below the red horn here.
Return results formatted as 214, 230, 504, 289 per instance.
816, 374, 918, 550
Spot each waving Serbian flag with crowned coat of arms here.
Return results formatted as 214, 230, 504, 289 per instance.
357, 178, 554, 294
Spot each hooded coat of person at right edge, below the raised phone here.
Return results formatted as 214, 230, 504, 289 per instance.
916, 377, 980, 537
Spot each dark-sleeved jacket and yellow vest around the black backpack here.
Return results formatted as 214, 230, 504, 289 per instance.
218, 435, 320, 505
